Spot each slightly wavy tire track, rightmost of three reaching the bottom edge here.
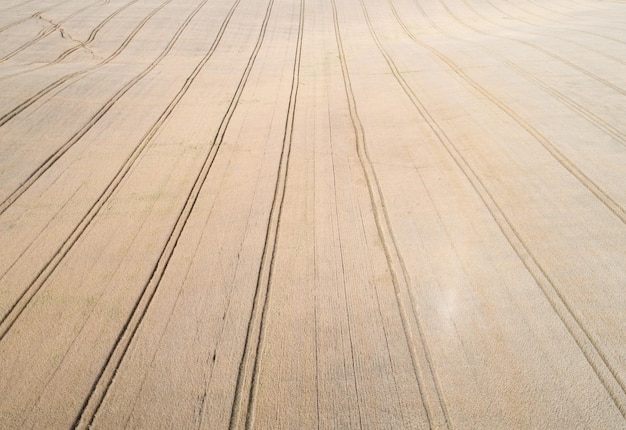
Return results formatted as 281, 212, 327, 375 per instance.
331, 0, 451, 428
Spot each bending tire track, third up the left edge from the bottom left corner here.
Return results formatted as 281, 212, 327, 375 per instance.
0, 0, 173, 128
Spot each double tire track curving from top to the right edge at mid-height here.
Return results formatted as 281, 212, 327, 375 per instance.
410, 2, 626, 224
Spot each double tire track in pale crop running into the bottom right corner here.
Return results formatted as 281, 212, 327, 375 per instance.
378, 0, 626, 418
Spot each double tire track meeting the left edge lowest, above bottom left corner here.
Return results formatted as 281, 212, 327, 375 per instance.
0, 0, 222, 341
